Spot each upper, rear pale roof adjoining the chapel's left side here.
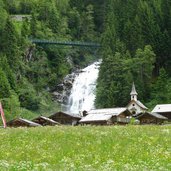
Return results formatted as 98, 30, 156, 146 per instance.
87, 107, 127, 116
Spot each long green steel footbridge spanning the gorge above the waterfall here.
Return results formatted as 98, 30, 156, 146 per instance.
30, 39, 101, 48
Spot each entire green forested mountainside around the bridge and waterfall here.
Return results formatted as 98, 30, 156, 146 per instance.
0, 0, 171, 120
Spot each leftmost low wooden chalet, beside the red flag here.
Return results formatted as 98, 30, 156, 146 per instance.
7, 118, 41, 127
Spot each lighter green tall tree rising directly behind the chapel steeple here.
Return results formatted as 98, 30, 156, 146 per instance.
132, 46, 156, 101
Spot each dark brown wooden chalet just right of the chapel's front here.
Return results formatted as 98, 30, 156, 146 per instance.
133, 112, 168, 125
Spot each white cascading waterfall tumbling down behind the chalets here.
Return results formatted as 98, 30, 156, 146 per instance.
68, 61, 101, 114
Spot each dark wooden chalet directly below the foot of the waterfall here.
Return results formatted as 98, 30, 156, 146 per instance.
49, 112, 81, 125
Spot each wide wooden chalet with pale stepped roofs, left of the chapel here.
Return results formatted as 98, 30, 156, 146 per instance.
79, 108, 131, 125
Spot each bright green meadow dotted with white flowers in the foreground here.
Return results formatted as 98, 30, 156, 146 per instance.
0, 126, 171, 171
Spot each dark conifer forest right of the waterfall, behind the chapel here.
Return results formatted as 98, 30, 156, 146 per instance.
96, 0, 171, 107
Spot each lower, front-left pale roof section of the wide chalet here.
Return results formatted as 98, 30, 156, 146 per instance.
79, 114, 112, 122
